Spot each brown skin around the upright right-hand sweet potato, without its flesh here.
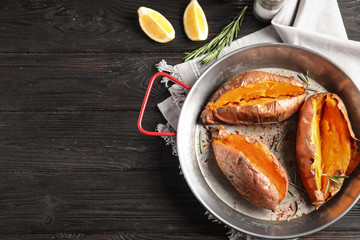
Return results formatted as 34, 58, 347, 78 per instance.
296, 92, 359, 209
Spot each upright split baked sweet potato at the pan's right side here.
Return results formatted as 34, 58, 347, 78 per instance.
296, 93, 360, 208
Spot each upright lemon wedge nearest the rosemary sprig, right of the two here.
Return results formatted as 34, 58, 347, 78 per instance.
183, 0, 209, 41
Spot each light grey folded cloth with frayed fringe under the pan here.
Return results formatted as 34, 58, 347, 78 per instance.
157, 0, 360, 240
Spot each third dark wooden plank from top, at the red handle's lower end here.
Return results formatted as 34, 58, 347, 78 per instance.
0, 111, 179, 173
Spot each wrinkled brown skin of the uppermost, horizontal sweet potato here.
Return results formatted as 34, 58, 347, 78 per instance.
200, 71, 306, 125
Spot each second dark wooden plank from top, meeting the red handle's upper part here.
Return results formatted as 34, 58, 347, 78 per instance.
0, 53, 179, 111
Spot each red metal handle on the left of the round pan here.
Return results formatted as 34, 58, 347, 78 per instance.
138, 72, 190, 136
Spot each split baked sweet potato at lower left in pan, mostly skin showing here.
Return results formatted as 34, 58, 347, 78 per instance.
212, 126, 288, 211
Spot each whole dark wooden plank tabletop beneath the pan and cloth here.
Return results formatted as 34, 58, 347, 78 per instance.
0, 0, 360, 240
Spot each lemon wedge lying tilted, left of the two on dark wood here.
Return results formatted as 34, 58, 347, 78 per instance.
138, 7, 175, 43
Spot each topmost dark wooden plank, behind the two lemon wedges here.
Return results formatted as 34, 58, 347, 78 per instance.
0, 0, 264, 53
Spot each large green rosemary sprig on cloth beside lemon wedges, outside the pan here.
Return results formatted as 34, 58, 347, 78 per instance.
183, 6, 247, 64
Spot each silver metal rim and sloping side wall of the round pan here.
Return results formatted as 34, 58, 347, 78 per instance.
177, 44, 360, 239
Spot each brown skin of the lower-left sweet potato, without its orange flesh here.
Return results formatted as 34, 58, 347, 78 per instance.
212, 126, 288, 211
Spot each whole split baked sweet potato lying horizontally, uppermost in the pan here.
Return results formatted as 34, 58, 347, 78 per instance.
200, 71, 307, 125
